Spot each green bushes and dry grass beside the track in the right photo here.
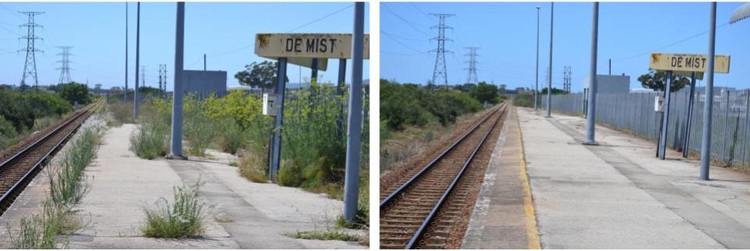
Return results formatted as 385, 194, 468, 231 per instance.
380, 80, 506, 173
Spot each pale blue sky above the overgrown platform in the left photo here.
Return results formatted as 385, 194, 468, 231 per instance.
0, 2, 370, 90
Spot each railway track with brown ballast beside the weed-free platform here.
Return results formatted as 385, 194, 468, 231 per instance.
380, 103, 509, 249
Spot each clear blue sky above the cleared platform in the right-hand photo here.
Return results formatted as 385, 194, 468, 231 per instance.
380, 2, 750, 91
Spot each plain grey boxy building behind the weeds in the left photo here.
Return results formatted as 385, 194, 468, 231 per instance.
183, 70, 227, 98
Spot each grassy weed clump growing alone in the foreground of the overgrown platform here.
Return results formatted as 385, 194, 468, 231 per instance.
141, 182, 205, 238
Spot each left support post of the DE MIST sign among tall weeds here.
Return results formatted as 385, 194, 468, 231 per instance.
268, 58, 287, 180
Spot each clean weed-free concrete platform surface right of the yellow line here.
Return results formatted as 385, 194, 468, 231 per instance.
516, 108, 750, 249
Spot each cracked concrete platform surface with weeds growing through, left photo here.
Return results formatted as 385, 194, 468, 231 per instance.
0, 124, 366, 249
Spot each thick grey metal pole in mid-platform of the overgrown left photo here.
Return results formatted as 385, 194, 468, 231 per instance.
165, 2, 187, 160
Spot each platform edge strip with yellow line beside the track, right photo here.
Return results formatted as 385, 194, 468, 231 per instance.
461, 108, 539, 249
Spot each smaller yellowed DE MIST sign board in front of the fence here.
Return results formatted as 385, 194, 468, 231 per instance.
649, 53, 729, 73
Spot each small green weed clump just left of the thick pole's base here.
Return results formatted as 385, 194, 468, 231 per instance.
130, 121, 168, 159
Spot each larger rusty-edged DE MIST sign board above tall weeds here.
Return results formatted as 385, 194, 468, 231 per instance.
255, 33, 370, 61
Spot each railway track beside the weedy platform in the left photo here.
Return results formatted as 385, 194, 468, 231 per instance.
0, 103, 101, 215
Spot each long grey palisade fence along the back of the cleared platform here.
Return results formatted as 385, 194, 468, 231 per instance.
541, 88, 750, 165
